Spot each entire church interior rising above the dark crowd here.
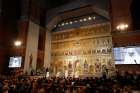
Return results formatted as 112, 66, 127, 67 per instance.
0, 0, 140, 77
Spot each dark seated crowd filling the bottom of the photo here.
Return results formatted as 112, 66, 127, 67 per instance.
0, 72, 140, 93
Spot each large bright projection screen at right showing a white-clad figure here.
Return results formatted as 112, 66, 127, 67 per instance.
114, 47, 140, 64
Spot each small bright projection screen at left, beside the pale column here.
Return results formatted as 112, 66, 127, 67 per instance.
9, 57, 22, 68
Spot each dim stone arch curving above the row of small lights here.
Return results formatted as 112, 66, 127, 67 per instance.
46, 0, 110, 30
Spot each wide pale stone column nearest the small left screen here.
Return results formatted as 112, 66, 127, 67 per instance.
24, 21, 39, 73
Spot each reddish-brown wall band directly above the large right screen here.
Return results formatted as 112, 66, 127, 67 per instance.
112, 30, 140, 47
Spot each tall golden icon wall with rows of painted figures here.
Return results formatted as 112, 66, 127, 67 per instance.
51, 23, 114, 77
